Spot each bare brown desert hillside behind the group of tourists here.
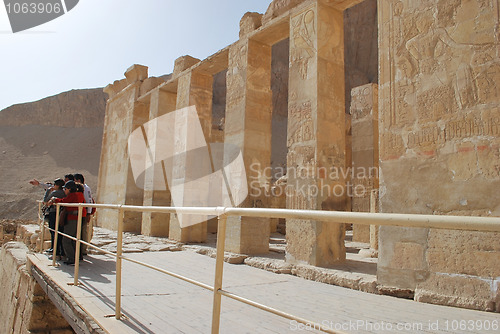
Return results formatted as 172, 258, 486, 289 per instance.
0, 88, 107, 219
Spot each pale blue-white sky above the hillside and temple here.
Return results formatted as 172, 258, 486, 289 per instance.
0, 0, 271, 110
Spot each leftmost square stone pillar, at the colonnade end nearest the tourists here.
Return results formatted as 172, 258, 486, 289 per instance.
97, 65, 149, 232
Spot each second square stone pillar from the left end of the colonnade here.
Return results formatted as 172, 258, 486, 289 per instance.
141, 88, 177, 237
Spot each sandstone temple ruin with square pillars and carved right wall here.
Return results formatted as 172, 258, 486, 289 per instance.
97, 0, 500, 312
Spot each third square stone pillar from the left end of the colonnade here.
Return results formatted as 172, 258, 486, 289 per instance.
169, 71, 213, 242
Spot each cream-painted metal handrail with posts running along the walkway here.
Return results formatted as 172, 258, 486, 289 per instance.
39, 202, 500, 333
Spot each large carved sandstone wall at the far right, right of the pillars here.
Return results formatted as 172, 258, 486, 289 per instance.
378, 0, 500, 309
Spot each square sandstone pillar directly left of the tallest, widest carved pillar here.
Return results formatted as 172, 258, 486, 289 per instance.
224, 39, 272, 254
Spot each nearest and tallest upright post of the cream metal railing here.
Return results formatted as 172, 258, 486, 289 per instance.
212, 214, 227, 334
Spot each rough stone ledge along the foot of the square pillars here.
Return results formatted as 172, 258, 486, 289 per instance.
87, 227, 377, 293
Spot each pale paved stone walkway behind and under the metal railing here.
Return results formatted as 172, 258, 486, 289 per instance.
30, 251, 500, 334
